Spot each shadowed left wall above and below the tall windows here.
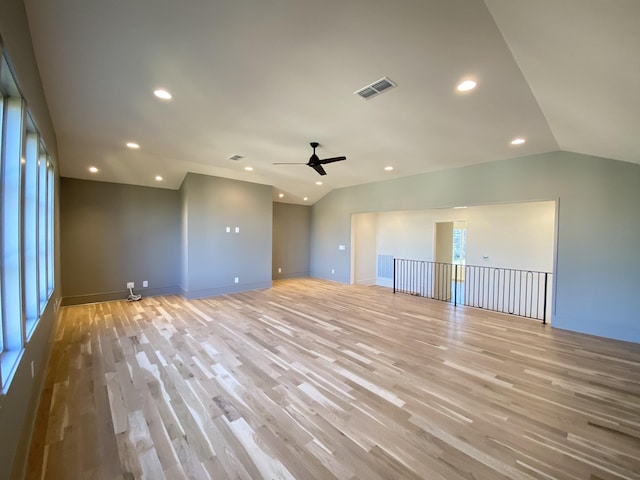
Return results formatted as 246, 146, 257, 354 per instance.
0, 0, 60, 479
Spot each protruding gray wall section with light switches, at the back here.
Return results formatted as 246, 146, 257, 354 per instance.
176, 173, 273, 298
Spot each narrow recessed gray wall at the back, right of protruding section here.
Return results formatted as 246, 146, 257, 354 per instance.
272, 203, 311, 279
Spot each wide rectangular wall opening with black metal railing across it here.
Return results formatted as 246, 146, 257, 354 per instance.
350, 200, 557, 322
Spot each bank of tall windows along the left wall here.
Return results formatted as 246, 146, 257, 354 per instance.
0, 51, 55, 392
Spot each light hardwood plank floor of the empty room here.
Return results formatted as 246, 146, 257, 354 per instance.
28, 279, 640, 480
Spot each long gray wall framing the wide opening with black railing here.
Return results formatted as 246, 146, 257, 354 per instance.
311, 152, 640, 342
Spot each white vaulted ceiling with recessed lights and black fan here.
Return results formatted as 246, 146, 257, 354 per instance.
25, 0, 640, 204
